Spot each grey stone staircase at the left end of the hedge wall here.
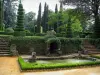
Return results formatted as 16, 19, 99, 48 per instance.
0, 36, 10, 56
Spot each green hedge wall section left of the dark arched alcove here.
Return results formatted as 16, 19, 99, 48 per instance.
10, 36, 46, 55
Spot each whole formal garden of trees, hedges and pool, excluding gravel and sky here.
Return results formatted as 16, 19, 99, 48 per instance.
0, 0, 100, 71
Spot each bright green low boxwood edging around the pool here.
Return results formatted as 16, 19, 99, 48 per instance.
18, 57, 100, 71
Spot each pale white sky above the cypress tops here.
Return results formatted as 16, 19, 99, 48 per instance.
22, 0, 75, 15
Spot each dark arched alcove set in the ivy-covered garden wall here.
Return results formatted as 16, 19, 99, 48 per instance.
46, 38, 62, 55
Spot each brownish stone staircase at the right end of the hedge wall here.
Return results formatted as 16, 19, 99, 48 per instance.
83, 40, 100, 54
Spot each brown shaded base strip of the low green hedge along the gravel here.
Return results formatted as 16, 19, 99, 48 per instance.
18, 58, 100, 72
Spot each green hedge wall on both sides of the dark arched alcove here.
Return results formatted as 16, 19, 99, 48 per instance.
10, 36, 82, 55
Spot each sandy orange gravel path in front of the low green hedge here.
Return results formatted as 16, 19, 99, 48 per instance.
0, 57, 100, 75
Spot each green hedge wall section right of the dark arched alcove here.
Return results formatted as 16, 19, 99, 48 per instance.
59, 37, 83, 54
